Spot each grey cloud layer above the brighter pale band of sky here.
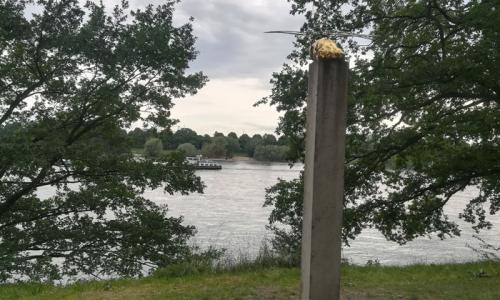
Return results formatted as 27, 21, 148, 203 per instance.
174, 0, 302, 82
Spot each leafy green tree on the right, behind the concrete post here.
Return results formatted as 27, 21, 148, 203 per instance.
260, 0, 500, 253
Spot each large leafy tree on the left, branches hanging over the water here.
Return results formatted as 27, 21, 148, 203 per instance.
0, 0, 206, 282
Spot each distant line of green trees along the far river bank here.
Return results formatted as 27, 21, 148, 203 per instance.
127, 128, 288, 161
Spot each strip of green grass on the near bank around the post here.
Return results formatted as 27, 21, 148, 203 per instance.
0, 262, 500, 300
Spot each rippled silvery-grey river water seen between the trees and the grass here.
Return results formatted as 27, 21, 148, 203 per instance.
145, 161, 500, 265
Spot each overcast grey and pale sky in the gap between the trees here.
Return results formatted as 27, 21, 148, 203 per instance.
162, 0, 303, 135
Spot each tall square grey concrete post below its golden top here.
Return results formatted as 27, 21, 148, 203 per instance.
301, 58, 349, 300
